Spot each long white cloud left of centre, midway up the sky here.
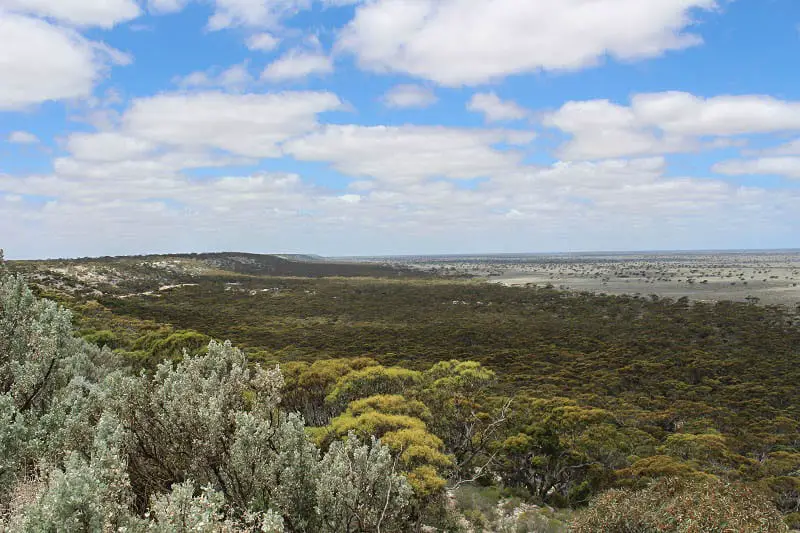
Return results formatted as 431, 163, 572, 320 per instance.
122, 92, 342, 157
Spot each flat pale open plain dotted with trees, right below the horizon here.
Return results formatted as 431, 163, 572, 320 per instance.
372, 250, 800, 308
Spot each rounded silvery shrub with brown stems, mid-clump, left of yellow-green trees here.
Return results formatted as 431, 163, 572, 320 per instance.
107, 342, 290, 505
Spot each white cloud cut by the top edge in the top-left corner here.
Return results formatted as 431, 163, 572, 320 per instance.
0, 0, 141, 28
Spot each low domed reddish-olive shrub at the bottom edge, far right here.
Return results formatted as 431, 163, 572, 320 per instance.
572, 478, 788, 533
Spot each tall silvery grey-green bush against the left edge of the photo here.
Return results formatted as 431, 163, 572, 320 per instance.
0, 275, 113, 507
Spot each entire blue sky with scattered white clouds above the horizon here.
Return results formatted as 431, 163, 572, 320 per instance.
0, 0, 800, 258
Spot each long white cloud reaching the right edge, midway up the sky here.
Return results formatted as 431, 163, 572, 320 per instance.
543, 92, 800, 159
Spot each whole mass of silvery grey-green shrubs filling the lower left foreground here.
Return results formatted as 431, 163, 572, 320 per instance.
0, 274, 411, 533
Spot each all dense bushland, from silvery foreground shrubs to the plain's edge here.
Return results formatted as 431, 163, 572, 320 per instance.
0, 256, 800, 532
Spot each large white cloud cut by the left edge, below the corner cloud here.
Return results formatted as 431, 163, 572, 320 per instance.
0, 10, 129, 110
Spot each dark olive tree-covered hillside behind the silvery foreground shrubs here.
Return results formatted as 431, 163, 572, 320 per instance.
3, 254, 800, 531
